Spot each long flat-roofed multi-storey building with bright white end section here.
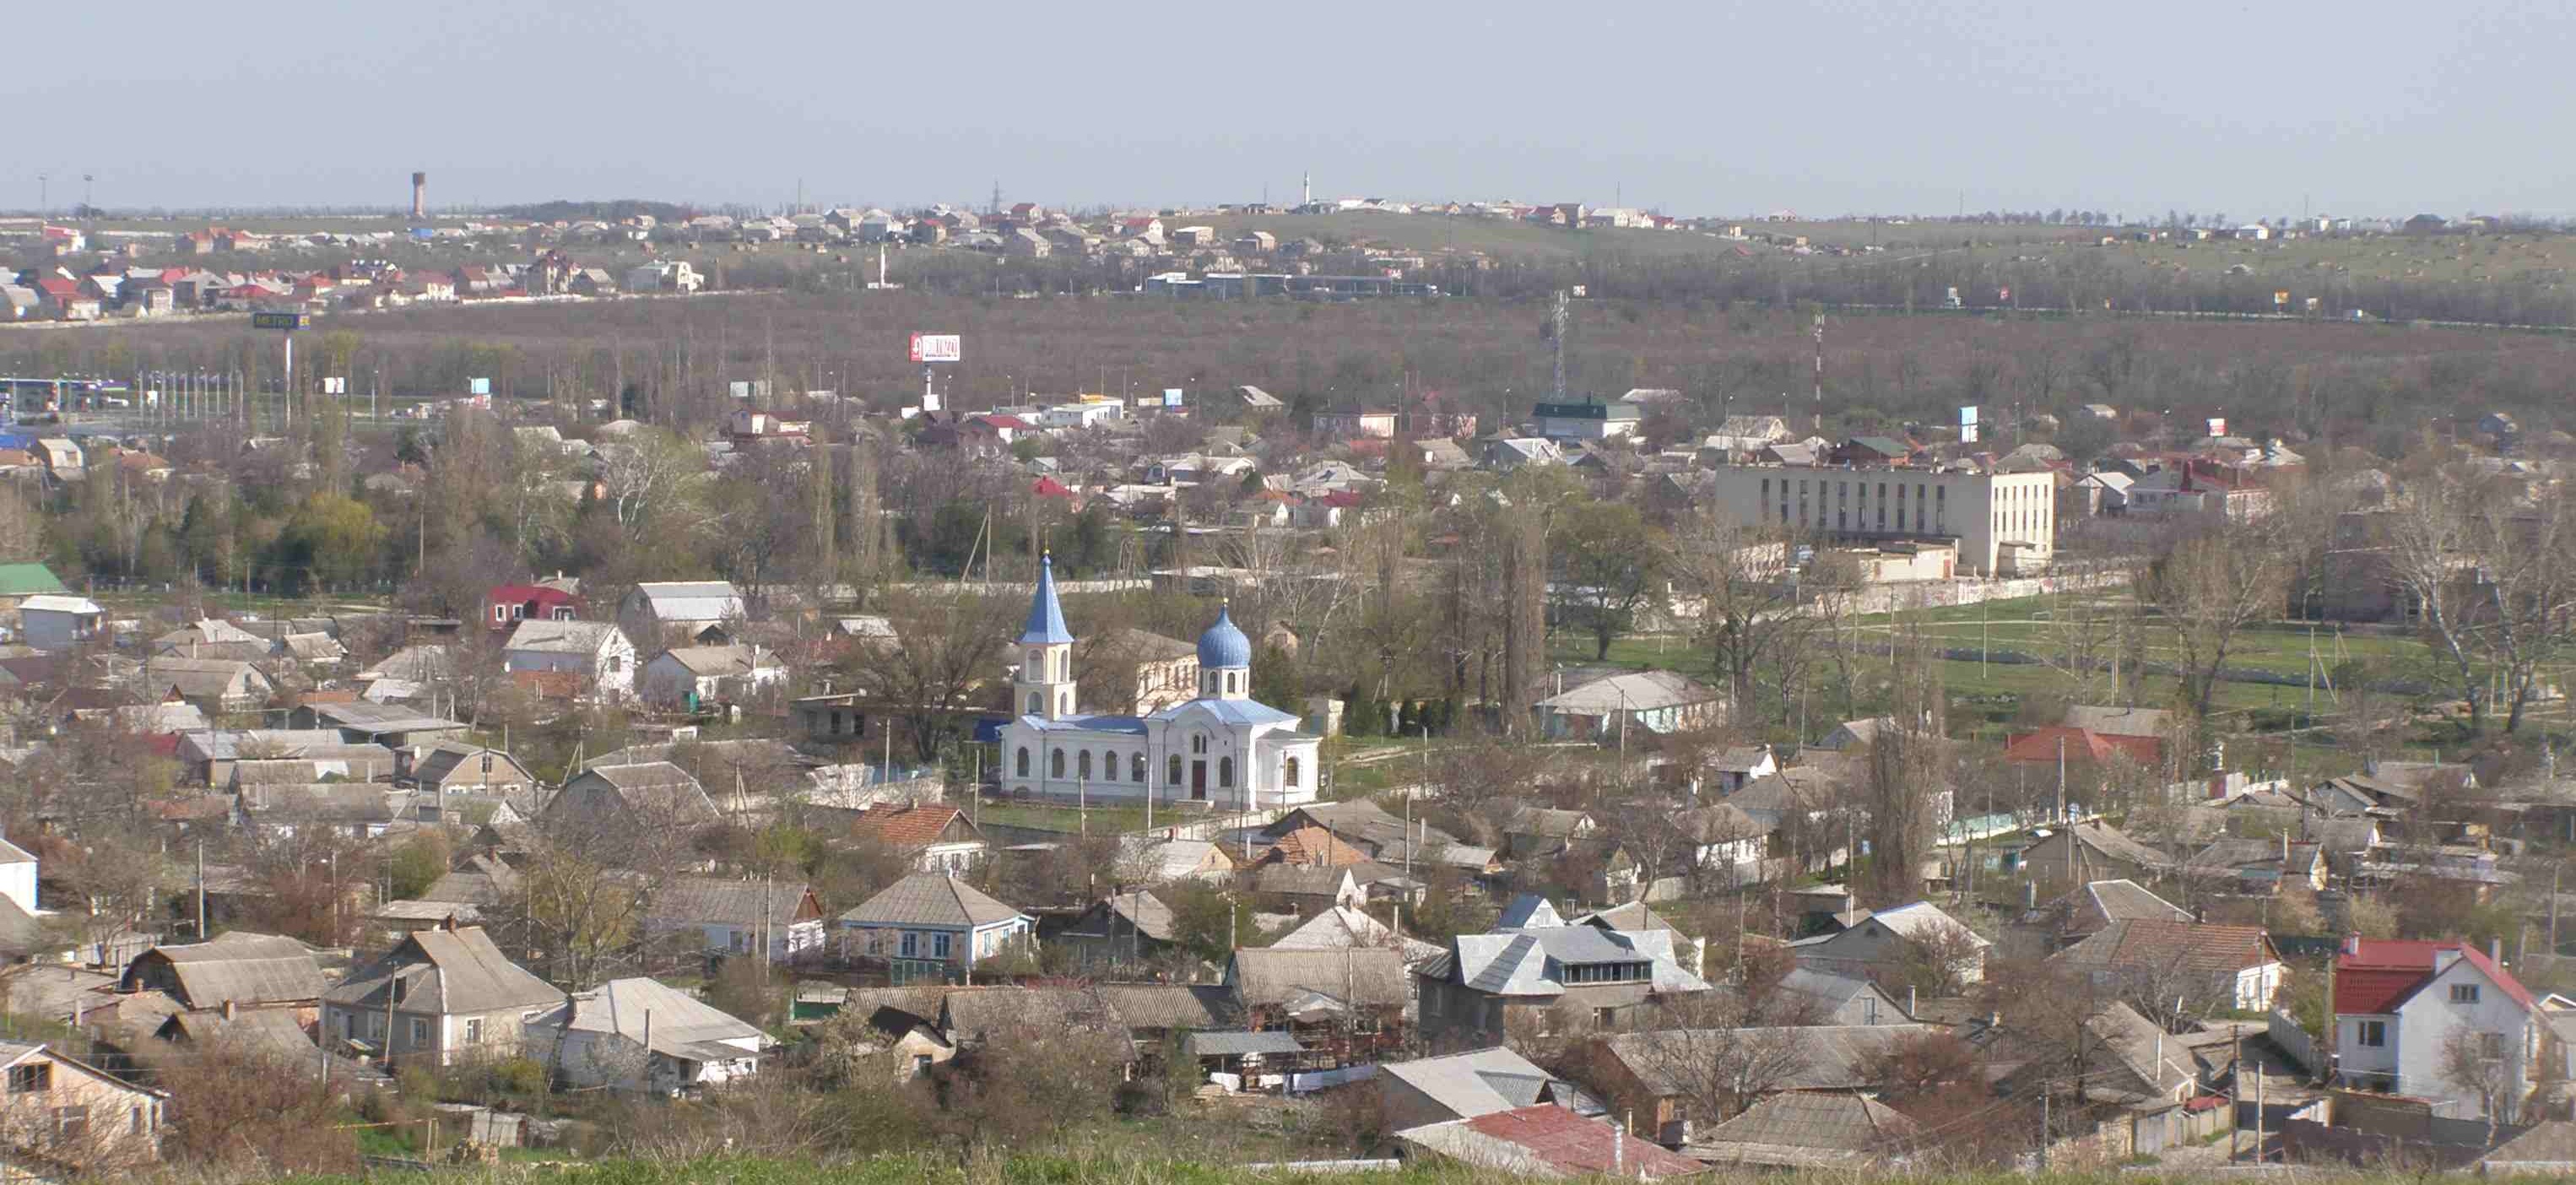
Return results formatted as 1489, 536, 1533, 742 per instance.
1705, 466, 2059, 577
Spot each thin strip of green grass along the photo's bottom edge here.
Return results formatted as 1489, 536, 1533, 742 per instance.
266, 1156, 2452, 1185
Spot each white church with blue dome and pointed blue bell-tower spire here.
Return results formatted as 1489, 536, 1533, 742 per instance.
1002, 559, 1322, 809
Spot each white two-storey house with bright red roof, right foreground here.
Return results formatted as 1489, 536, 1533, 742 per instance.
2334, 935, 2563, 1123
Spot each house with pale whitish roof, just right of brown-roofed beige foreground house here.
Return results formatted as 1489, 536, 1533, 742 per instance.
523, 979, 765, 1095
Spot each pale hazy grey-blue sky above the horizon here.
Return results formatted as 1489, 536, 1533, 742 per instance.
14, 0, 2576, 219
